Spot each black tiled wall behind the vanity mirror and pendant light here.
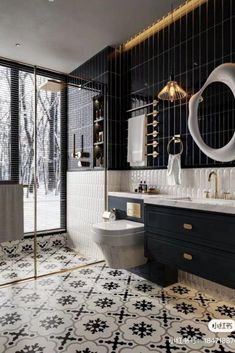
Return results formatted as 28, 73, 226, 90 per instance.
121, 0, 235, 168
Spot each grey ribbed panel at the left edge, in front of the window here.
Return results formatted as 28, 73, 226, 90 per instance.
0, 184, 24, 243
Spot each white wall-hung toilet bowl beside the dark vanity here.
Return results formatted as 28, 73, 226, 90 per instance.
92, 219, 147, 269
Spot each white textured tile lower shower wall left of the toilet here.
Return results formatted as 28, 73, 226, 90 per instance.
67, 171, 105, 261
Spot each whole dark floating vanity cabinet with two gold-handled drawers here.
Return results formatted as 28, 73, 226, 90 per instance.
145, 204, 235, 288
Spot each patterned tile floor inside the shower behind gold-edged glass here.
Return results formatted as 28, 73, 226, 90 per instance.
0, 234, 94, 284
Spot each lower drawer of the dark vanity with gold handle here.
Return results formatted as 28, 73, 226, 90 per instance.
145, 233, 235, 288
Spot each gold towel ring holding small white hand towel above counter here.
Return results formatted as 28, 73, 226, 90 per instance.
167, 135, 184, 185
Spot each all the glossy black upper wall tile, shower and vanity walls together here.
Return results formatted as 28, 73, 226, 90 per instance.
68, 0, 235, 170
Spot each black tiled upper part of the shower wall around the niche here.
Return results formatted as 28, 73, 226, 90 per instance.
68, 47, 121, 171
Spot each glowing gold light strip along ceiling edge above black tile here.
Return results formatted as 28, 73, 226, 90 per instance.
121, 0, 208, 51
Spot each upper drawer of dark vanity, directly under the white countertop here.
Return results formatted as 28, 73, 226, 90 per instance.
145, 205, 235, 252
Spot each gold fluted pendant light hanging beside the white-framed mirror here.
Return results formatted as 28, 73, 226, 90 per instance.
158, 4, 187, 102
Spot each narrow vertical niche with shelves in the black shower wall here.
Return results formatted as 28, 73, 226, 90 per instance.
93, 95, 105, 169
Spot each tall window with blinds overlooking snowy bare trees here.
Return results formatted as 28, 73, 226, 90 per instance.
0, 66, 66, 233
